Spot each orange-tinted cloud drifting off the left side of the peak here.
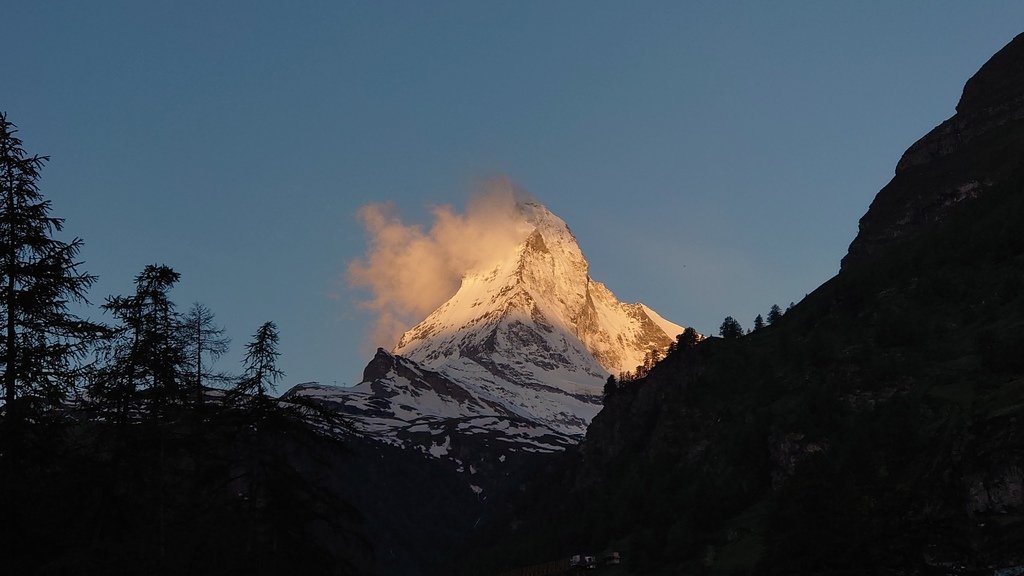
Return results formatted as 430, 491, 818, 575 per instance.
347, 178, 530, 348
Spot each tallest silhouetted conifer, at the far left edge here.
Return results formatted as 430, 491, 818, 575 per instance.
0, 113, 102, 419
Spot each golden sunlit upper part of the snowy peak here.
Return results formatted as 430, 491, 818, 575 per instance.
392, 201, 683, 377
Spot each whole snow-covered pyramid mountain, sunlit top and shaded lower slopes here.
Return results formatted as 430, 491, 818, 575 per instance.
290, 202, 683, 456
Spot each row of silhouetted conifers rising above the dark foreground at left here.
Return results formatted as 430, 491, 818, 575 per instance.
0, 113, 296, 426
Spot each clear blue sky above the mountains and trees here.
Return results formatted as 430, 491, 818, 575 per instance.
0, 0, 1024, 389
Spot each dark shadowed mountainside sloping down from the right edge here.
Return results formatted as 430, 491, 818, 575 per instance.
456, 36, 1024, 574
